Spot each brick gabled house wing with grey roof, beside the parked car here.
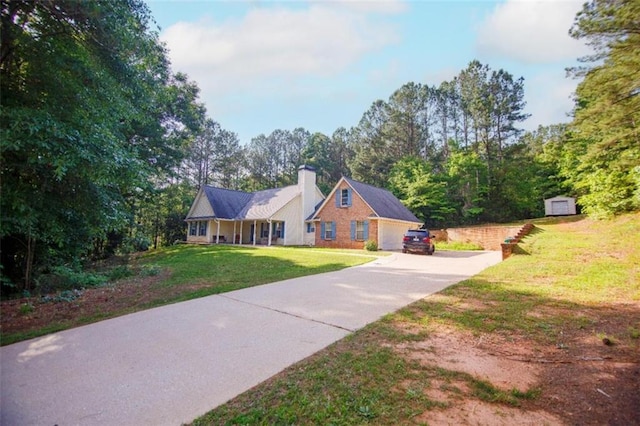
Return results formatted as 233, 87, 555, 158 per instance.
307, 177, 422, 250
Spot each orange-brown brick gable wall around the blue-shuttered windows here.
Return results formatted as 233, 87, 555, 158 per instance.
316, 182, 378, 249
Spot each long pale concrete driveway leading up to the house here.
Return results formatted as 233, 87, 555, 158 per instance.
0, 252, 501, 426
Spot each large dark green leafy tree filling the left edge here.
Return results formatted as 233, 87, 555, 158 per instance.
0, 0, 202, 290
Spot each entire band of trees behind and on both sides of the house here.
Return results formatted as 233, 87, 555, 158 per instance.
0, 0, 640, 292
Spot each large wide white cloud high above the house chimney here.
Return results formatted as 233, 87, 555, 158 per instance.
161, 4, 398, 93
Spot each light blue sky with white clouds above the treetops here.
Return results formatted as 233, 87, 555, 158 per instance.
147, 0, 588, 143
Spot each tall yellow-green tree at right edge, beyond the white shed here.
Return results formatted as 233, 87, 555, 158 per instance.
563, 0, 640, 216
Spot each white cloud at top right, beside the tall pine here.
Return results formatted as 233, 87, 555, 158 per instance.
477, 0, 589, 63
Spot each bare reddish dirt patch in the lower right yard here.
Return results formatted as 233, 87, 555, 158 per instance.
395, 310, 640, 426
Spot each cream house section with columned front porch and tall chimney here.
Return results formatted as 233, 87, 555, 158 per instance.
185, 166, 324, 245
